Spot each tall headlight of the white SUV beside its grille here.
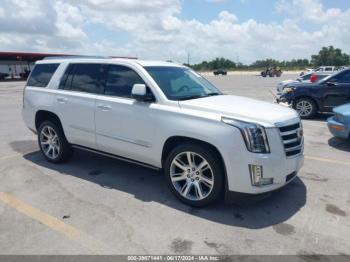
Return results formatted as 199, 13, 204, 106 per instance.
221, 117, 270, 153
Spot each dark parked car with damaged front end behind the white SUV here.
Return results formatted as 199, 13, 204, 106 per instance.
277, 69, 350, 118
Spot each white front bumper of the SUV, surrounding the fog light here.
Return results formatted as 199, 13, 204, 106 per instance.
223, 128, 304, 194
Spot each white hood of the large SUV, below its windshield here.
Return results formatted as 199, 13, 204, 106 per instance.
179, 95, 299, 127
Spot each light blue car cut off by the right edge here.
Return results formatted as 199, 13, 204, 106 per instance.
327, 104, 350, 139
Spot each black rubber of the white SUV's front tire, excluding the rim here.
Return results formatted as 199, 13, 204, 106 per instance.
164, 144, 225, 207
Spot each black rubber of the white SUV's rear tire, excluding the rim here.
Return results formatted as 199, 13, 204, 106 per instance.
38, 121, 73, 163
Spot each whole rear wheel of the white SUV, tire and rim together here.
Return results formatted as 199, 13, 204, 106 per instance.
38, 121, 73, 163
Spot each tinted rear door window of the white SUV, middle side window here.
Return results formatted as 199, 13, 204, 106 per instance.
60, 64, 107, 94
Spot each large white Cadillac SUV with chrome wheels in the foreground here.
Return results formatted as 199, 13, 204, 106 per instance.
22, 58, 304, 206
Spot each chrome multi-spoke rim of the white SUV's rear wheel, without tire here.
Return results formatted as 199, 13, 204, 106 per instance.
39, 126, 61, 159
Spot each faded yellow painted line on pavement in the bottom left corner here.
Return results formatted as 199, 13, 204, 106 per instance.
0, 192, 110, 254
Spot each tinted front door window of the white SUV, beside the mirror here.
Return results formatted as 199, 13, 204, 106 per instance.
105, 65, 145, 98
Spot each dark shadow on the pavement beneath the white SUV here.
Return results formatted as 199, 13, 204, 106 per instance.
11, 141, 307, 229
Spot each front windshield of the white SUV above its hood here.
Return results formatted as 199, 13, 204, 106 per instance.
145, 66, 222, 100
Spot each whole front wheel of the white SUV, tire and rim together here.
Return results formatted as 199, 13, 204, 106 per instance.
164, 144, 224, 207
